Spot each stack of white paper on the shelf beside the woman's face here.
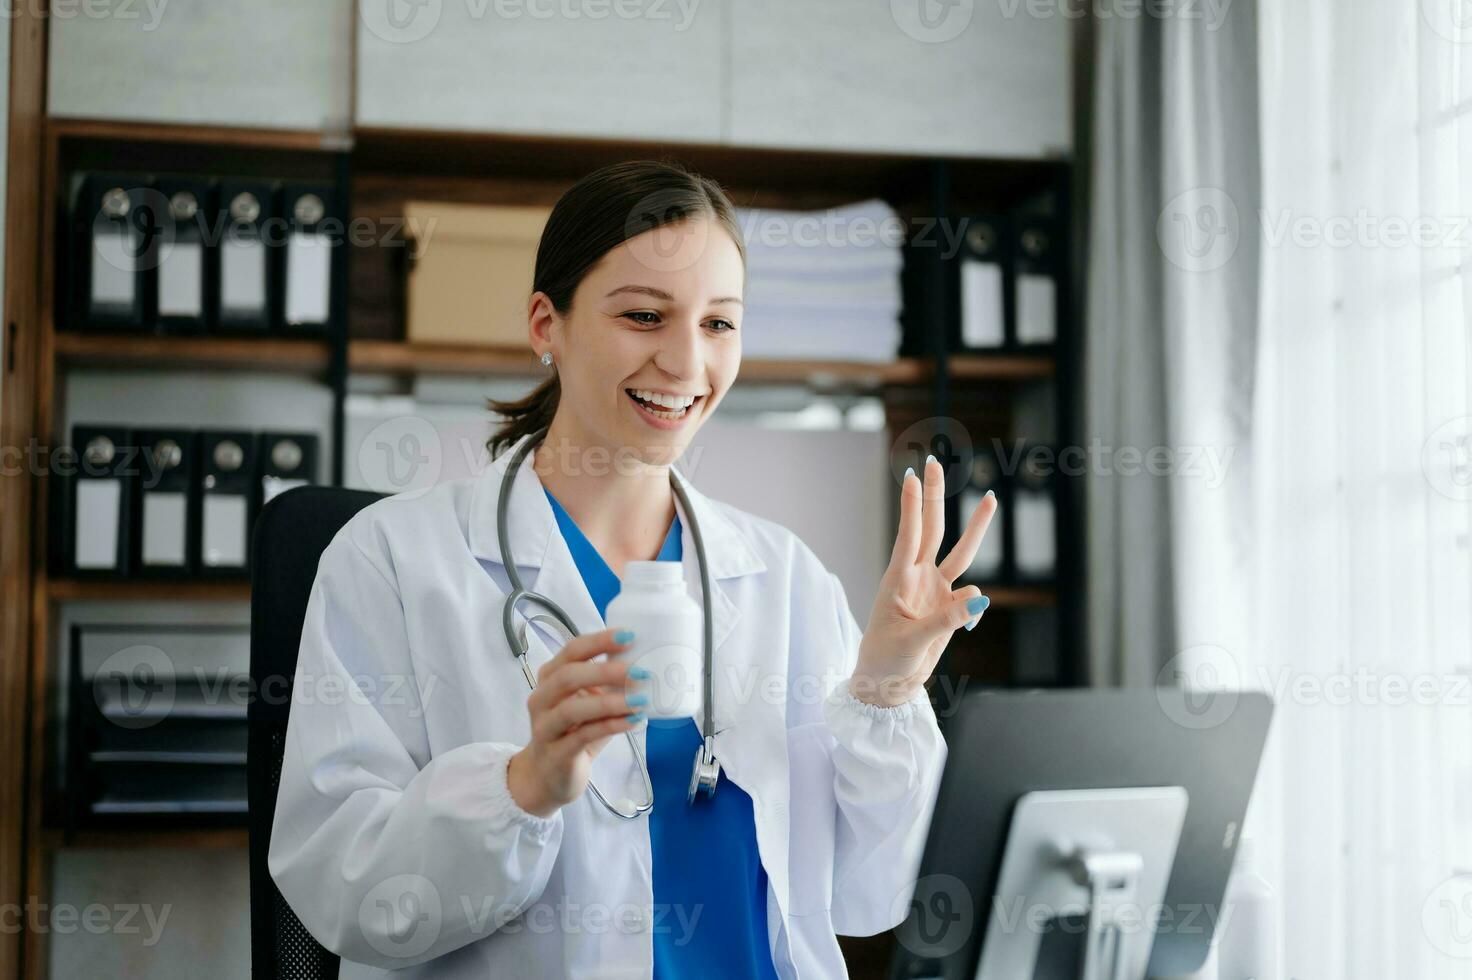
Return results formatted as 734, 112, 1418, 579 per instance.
737, 200, 907, 362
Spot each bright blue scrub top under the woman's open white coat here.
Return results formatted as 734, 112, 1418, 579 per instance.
543, 487, 777, 980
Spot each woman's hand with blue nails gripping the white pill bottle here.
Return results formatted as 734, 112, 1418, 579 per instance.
506, 630, 646, 817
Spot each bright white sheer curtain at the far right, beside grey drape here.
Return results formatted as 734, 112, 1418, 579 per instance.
1247, 0, 1472, 980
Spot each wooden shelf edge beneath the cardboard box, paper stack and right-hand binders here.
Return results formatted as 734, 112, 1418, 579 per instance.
347, 340, 1052, 387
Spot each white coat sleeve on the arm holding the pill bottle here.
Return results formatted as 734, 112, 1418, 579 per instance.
266, 525, 562, 970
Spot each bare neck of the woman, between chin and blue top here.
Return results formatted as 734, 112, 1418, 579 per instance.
531, 419, 676, 567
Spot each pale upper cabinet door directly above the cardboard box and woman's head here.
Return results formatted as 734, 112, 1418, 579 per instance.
358, 0, 727, 143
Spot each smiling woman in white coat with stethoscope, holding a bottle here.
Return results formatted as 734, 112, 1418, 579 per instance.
268, 162, 997, 980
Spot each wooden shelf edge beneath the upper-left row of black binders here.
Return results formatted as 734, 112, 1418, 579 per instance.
56, 331, 328, 374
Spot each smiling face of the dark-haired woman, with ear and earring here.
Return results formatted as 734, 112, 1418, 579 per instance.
531, 218, 745, 465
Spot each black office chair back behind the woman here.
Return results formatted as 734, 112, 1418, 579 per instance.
246, 487, 383, 980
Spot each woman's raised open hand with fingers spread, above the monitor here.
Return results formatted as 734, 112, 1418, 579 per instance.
849, 456, 997, 708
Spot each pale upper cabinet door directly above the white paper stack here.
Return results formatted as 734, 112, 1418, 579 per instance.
727, 0, 1073, 157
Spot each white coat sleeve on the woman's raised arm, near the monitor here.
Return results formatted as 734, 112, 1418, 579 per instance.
823, 572, 946, 936
